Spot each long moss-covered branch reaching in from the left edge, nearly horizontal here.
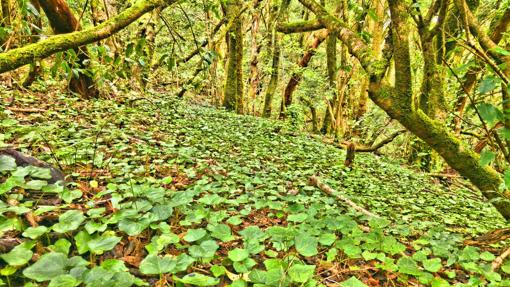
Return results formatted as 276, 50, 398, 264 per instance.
0, 0, 175, 73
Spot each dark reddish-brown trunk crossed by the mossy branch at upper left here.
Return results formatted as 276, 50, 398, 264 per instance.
39, 0, 98, 99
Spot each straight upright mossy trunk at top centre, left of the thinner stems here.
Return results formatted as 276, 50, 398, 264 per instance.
223, 0, 244, 114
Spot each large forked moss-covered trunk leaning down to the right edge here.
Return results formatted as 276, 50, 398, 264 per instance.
299, 0, 510, 220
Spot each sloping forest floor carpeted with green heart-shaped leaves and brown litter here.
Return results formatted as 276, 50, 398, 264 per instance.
0, 86, 510, 286
